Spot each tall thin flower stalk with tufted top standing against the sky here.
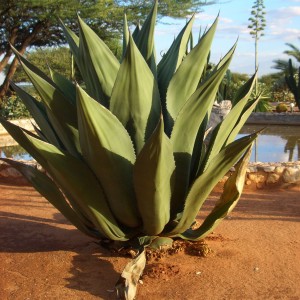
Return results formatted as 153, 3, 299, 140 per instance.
248, 0, 266, 93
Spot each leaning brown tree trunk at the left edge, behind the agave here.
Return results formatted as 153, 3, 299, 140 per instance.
0, 22, 45, 102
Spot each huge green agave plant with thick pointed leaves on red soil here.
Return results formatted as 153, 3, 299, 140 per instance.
1, 1, 258, 299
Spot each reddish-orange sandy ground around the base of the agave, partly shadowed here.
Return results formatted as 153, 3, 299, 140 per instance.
0, 183, 300, 300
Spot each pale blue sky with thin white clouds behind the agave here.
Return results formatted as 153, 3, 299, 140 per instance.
156, 0, 300, 76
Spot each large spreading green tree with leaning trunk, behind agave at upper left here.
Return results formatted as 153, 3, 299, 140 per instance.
0, 0, 220, 99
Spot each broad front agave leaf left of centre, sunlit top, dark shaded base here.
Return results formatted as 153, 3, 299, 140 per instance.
77, 86, 140, 227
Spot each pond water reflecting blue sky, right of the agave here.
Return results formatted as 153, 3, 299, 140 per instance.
239, 125, 300, 162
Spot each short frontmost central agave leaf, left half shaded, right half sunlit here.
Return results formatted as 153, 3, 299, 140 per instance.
133, 120, 175, 235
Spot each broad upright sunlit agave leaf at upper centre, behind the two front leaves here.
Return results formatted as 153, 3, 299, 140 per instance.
110, 37, 161, 153
